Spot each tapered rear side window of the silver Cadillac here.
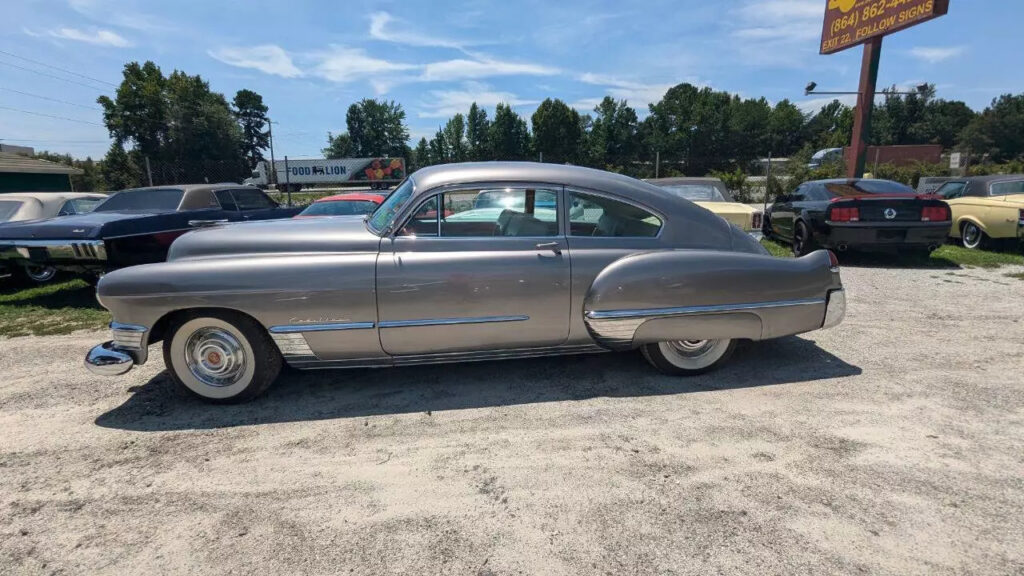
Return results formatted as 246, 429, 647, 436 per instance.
569, 192, 663, 238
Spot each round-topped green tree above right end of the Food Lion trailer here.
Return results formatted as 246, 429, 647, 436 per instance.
345, 98, 409, 157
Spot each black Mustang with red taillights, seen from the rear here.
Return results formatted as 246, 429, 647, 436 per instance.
764, 179, 950, 256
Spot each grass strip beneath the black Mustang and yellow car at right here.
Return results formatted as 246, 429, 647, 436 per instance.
761, 240, 1024, 269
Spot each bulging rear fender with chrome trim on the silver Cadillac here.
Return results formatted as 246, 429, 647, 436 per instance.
584, 250, 842, 349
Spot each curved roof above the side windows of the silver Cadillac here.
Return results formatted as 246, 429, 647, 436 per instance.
410, 162, 672, 209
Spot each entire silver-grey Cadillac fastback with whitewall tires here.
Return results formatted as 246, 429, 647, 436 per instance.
86, 162, 846, 402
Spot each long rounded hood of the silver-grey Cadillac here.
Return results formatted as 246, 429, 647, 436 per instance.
167, 215, 380, 261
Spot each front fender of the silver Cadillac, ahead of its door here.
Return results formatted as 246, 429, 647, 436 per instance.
96, 252, 380, 357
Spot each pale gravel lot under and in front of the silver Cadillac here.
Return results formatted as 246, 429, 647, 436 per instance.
0, 268, 1024, 574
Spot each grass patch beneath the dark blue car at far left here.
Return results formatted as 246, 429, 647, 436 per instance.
0, 280, 111, 337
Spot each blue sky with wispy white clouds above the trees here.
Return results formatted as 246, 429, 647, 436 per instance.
0, 0, 1024, 157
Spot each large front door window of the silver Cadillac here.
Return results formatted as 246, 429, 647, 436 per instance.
440, 188, 558, 238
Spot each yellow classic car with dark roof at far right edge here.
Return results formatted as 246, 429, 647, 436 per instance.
936, 174, 1024, 249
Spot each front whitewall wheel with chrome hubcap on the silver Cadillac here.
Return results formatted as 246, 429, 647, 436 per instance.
164, 312, 283, 404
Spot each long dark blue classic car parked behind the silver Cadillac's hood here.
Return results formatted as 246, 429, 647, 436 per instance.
0, 184, 302, 275
